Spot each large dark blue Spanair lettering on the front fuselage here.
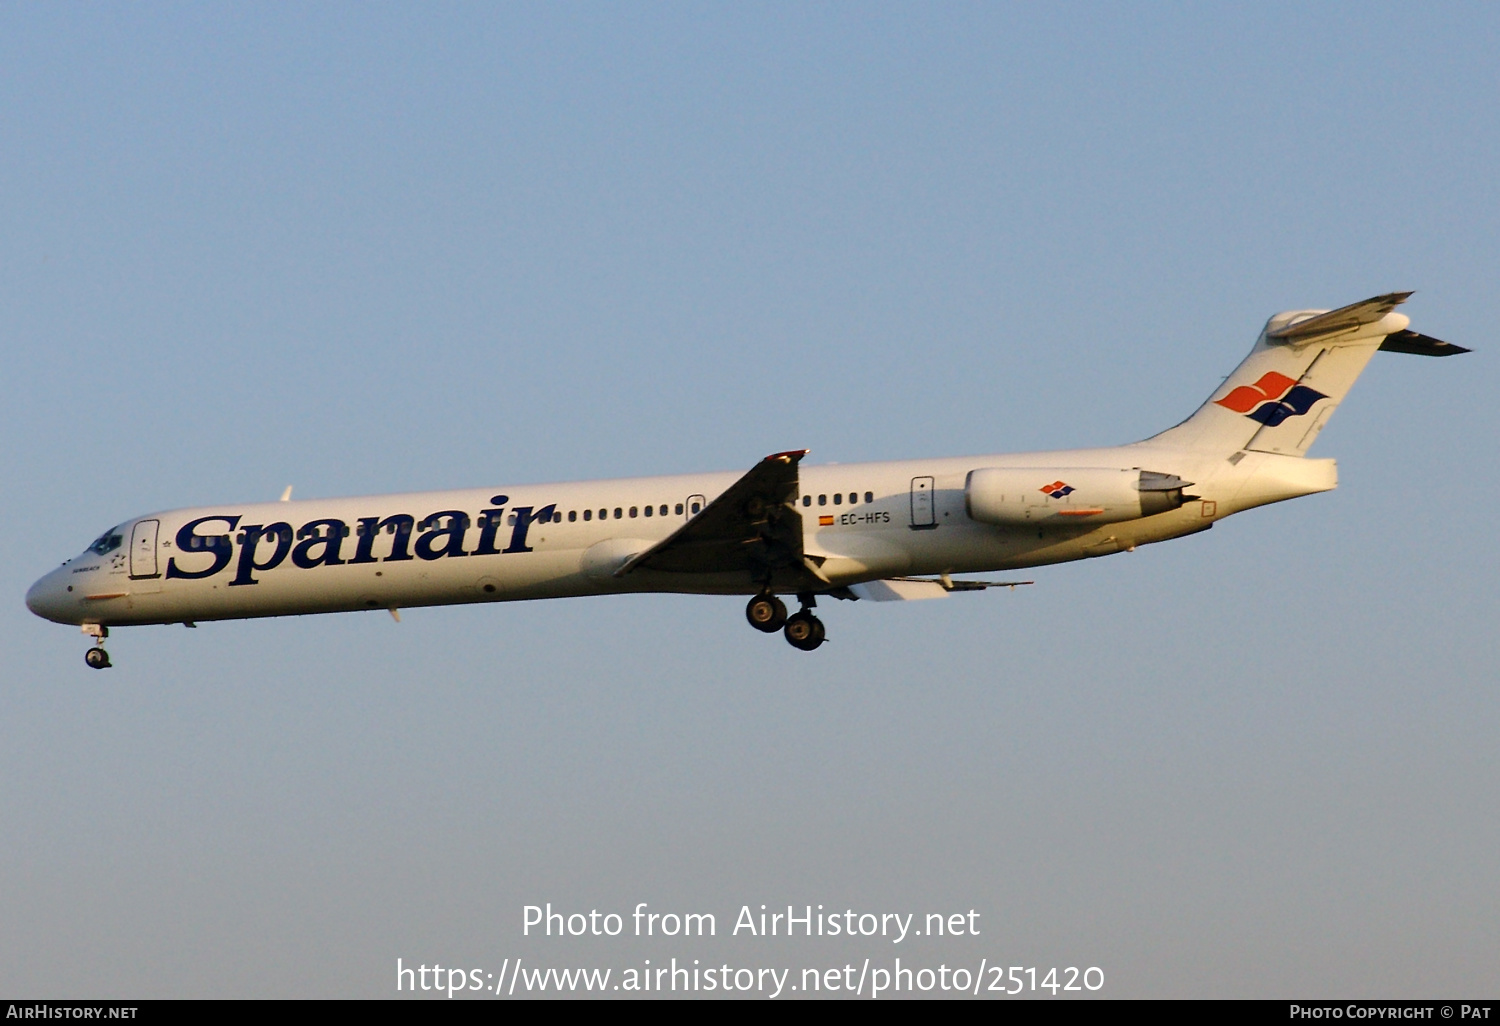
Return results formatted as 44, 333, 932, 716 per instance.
167, 495, 561, 587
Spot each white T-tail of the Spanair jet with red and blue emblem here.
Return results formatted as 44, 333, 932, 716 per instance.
1149, 293, 1469, 456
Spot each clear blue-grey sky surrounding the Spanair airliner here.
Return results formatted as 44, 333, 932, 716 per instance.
0, 5, 1500, 996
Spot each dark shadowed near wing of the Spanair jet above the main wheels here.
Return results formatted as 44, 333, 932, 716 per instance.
615, 449, 828, 587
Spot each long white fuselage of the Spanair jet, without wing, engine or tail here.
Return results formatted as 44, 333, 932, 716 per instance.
27, 441, 1335, 627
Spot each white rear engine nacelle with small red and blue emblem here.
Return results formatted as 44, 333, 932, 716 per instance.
963, 467, 1193, 527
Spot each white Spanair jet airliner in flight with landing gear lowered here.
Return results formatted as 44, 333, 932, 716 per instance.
26, 293, 1469, 669
